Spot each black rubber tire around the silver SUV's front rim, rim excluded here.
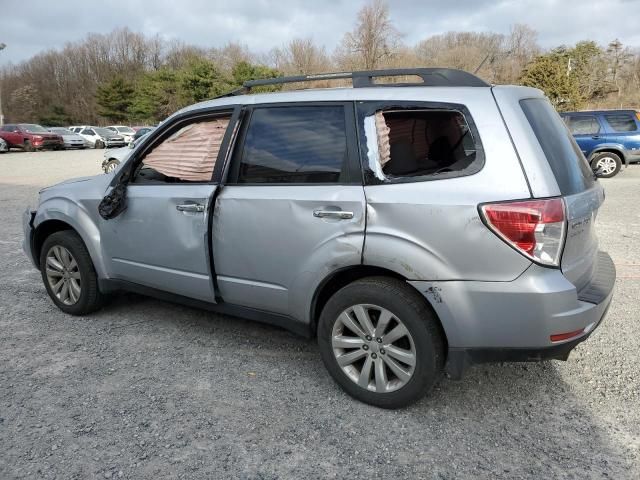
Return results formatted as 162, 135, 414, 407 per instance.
40, 230, 103, 315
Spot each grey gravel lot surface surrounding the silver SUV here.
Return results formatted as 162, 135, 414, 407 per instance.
0, 151, 640, 479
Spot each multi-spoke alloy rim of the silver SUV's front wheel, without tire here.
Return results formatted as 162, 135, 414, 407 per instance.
45, 245, 82, 305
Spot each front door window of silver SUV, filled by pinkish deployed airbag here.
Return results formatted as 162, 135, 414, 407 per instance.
135, 116, 231, 183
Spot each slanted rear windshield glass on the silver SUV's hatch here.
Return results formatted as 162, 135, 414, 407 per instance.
520, 98, 595, 195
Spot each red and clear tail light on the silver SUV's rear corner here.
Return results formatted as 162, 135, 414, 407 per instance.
480, 198, 566, 267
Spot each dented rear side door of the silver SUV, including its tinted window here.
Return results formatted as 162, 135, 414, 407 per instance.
212, 103, 365, 319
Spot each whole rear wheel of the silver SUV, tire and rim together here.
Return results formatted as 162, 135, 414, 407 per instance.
318, 277, 445, 408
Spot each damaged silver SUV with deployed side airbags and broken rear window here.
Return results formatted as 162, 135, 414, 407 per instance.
24, 69, 615, 408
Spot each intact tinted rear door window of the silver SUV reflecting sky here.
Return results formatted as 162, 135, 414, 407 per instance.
237, 105, 347, 183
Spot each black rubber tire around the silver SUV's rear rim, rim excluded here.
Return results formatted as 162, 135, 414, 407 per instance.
318, 277, 445, 408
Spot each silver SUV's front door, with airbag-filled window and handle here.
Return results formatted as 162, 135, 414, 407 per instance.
100, 108, 240, 303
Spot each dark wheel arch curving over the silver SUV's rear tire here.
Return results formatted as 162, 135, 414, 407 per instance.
309, 265, 449, 352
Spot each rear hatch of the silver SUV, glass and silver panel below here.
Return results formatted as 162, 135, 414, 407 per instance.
520, 97, 604, 291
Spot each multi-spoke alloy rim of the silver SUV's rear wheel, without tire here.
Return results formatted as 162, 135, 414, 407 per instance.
331, 304, 416, 393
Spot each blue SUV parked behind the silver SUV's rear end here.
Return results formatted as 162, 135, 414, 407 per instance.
560, 110, 640, 178
